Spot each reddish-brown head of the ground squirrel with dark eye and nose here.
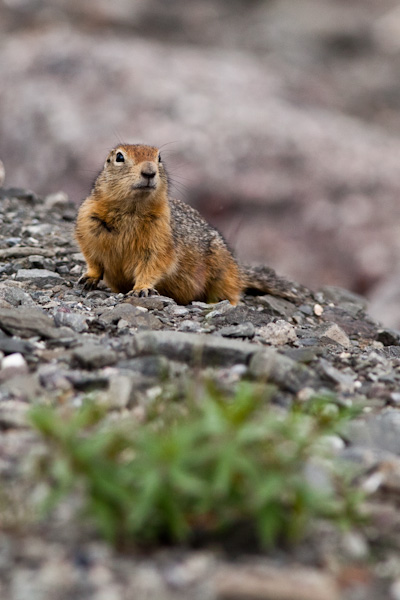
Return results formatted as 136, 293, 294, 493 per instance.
94, 144, 168, 199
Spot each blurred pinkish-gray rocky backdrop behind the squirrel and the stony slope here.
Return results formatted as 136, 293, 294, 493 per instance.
0, 0, 400, 328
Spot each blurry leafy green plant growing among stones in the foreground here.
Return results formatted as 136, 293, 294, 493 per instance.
30, 384, 364, 546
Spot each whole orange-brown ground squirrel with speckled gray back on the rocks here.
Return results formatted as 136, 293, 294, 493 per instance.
76, 145, 296, 304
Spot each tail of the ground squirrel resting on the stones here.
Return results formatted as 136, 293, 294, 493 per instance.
240, 265, 305, 303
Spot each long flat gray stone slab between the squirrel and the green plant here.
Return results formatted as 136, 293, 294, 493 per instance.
130, 331, 258, 366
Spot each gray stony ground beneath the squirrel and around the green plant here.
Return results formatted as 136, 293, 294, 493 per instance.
0, 188, 400, 600
